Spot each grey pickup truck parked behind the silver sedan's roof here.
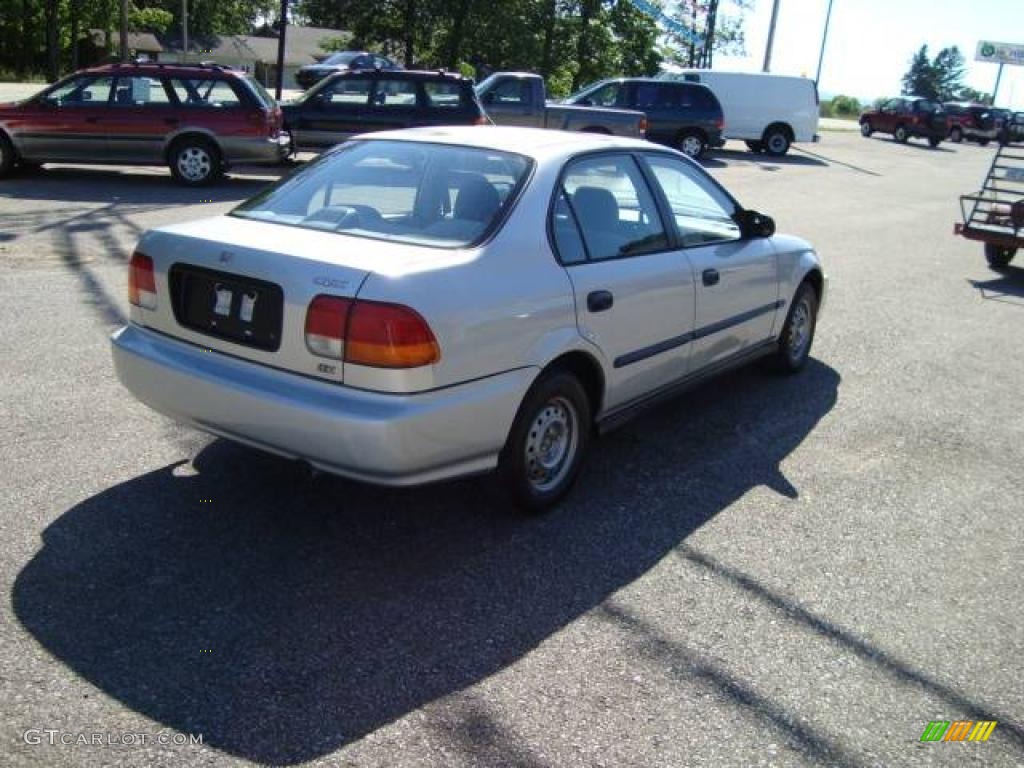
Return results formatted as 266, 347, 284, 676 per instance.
476, 72, 647, 138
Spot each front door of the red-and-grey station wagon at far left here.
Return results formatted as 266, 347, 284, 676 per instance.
18, 75, 113, 163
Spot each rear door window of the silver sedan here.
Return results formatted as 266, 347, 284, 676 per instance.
552, 155, 669, 263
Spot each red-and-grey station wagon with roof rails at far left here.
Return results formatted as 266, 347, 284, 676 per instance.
0, 63, 291, 186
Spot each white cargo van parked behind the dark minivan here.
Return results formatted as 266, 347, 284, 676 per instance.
659, 70, 818, 155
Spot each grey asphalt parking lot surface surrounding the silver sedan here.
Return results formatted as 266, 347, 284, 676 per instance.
0, 132, 1024, 768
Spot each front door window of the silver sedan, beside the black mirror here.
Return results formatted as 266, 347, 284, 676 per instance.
644, 155, 740, 248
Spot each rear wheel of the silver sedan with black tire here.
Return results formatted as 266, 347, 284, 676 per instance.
498, 369, 591, 514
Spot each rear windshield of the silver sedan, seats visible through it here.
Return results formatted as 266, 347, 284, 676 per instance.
231, 139, 530, 248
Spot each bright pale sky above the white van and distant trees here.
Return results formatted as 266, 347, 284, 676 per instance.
715, 0, 1024, 110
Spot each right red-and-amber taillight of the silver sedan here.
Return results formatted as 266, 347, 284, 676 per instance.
306, 295, 441, 368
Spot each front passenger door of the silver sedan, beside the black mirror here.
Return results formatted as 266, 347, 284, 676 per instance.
643, 153, 780, 372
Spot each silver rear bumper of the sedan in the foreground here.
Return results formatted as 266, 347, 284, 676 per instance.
111, 325, 537, 485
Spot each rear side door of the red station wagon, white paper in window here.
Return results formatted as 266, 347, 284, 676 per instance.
100, 75, 181, 163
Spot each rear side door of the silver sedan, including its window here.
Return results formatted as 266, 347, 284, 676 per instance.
551, 153, 695, 410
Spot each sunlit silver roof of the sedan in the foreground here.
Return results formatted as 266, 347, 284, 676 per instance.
356, 125, 655, 161
